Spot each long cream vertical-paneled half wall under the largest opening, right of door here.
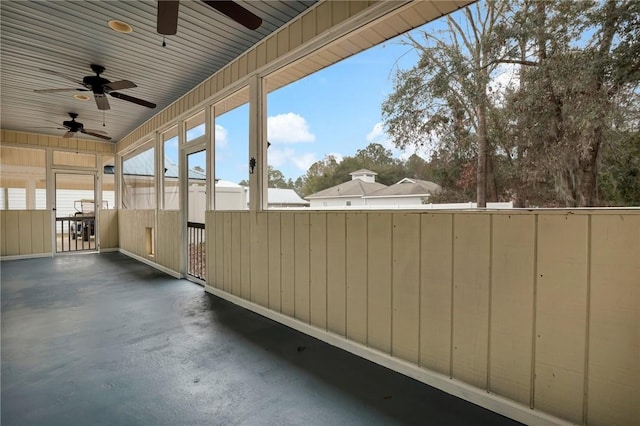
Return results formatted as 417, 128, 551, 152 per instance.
206, 210, 640, 425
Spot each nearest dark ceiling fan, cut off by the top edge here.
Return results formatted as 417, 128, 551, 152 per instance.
157, 0, 262, 35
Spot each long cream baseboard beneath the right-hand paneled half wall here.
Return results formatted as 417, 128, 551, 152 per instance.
204, 285, 573, 426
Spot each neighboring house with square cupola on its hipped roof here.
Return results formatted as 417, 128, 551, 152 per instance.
305, 169, 387, 208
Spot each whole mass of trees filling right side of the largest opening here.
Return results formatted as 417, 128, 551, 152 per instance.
382, 0, 640, 207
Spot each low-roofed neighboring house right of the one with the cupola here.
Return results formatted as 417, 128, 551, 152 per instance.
362, 178, 441, 207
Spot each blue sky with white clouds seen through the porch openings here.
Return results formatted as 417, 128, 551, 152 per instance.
172, 14, 458, 183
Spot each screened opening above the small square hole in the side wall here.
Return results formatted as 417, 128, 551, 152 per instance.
122, 143, 156, 210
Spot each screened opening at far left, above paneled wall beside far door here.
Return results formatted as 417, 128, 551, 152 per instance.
0, 146, 47, 210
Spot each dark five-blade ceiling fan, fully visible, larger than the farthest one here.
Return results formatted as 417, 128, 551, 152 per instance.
34, 64, 156, 110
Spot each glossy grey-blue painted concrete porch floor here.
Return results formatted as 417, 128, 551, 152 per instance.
0, 253, 516, 426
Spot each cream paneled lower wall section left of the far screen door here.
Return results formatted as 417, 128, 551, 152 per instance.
0, 210, 52, 256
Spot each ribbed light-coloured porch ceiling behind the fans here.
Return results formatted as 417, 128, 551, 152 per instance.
0, 0, 316, 142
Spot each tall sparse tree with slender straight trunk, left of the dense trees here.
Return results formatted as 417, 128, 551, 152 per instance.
382, 1, 506, 207
